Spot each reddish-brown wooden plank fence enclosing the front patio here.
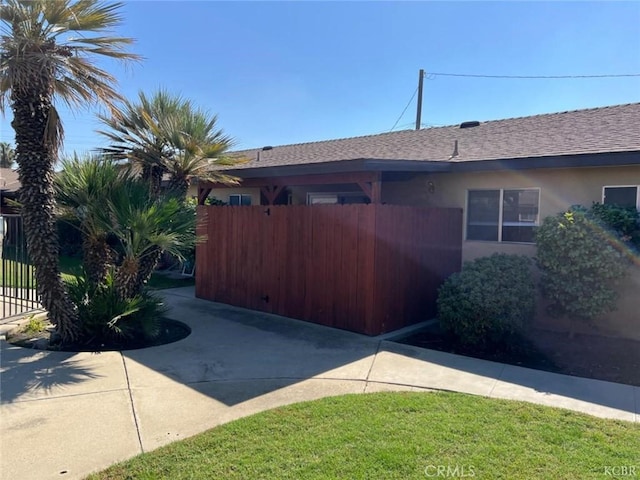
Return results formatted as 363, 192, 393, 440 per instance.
196, 204, 462, 335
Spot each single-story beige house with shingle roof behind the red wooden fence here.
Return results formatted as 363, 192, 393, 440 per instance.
199, 103, 640, 339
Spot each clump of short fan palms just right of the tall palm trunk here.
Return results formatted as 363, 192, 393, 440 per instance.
56, 157, 196, 299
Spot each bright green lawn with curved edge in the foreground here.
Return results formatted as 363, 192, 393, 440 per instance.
88, 392, 640, 480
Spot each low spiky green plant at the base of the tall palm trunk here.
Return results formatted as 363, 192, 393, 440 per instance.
67, 270, 165, 345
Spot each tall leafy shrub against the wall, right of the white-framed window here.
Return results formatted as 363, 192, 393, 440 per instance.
536, 207, 628, 326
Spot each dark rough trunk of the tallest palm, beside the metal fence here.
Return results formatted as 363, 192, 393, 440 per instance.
11, 89, 79, 343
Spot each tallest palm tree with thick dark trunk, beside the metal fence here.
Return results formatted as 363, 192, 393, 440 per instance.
0, 0, 139, 342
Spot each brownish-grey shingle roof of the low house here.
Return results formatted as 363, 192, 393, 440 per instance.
233, 103, 640, 170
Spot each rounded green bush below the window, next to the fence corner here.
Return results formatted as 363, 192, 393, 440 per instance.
438, 253, 536, 347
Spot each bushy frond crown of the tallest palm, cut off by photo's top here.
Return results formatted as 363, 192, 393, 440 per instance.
0, 0, 140, 116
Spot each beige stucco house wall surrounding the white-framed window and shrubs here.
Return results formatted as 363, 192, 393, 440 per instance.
382, 165, 640, 340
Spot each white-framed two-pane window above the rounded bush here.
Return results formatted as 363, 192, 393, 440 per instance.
467, 189, 540, 243
